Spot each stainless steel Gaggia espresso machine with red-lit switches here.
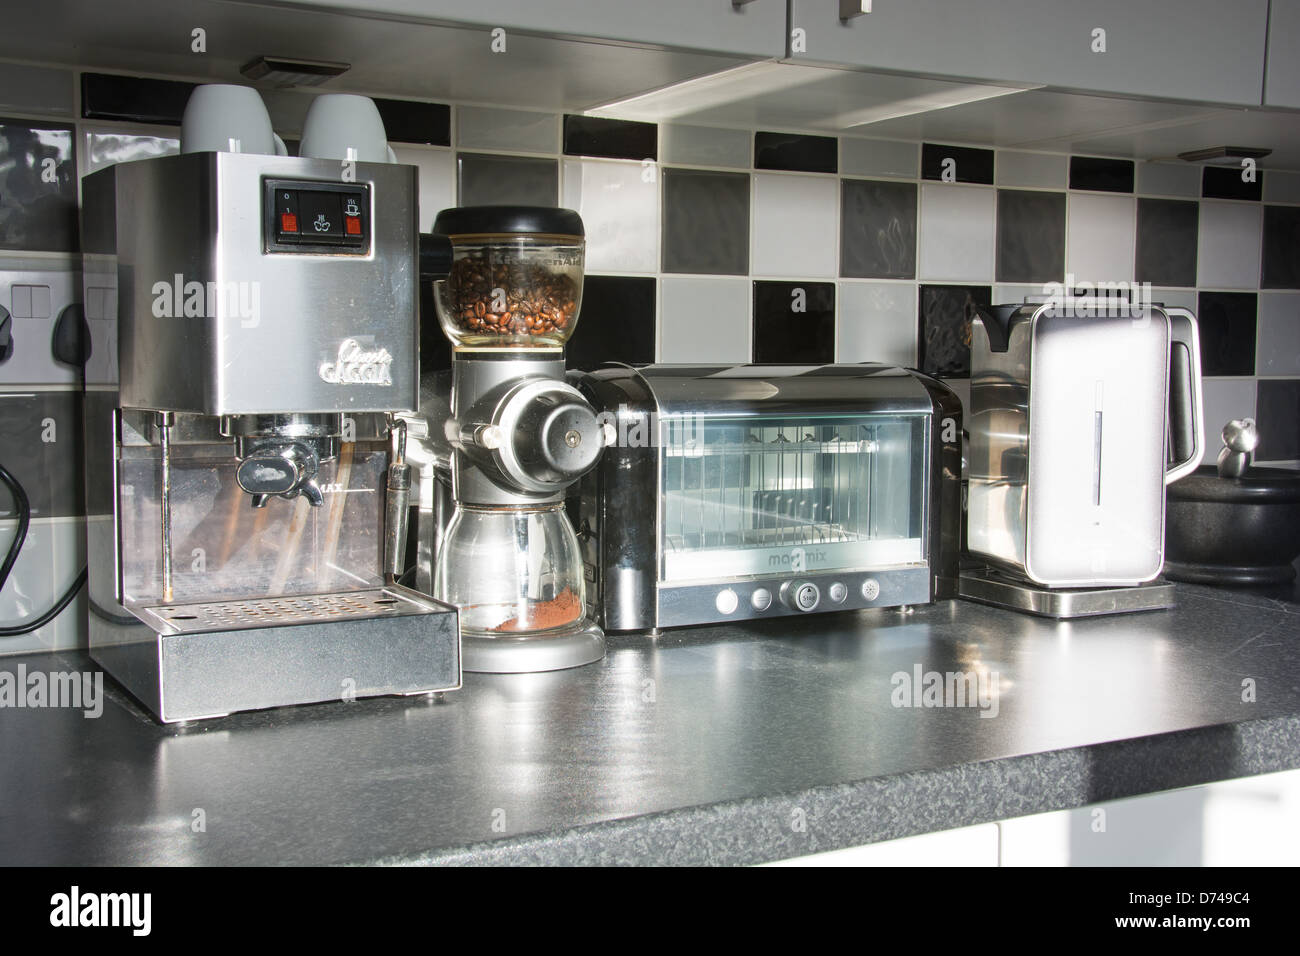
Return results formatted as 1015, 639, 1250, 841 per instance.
83, 152, 460, 722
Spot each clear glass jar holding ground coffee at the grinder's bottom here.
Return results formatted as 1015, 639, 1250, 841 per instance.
433, 505, 586, 637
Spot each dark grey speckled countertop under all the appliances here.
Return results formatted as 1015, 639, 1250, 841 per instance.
0, 585, 1300, 864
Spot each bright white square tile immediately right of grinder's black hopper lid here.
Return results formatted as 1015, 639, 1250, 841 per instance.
563, 159, 659, 272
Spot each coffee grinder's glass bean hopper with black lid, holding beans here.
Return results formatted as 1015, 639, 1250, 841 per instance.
433, 206, 586, 351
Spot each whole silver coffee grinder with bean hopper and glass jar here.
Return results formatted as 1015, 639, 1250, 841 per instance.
430, 206, 612, 672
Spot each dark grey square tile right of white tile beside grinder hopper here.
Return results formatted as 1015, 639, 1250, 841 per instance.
663, 169, 749, 276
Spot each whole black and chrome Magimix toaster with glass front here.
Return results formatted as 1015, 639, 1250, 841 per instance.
569, 364, 961, 631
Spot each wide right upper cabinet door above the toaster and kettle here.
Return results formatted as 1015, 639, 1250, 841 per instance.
789, 0, 1268, 105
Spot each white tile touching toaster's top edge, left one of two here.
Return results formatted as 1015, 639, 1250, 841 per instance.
659, 278, 754, 364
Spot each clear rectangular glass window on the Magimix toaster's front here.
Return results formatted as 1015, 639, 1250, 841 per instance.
659, 414, 930, 581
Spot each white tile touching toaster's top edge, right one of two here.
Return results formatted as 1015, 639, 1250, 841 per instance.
835, 280, 917, 368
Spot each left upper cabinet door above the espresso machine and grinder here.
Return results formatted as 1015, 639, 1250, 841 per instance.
248, 0, 787, 59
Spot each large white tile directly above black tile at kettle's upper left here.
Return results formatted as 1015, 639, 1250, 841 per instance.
917, 182, 997, 282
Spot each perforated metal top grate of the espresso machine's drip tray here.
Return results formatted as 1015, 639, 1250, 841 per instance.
131, 588, 449, 633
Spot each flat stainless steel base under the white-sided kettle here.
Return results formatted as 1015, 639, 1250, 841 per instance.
957, 568, 1174, 619
